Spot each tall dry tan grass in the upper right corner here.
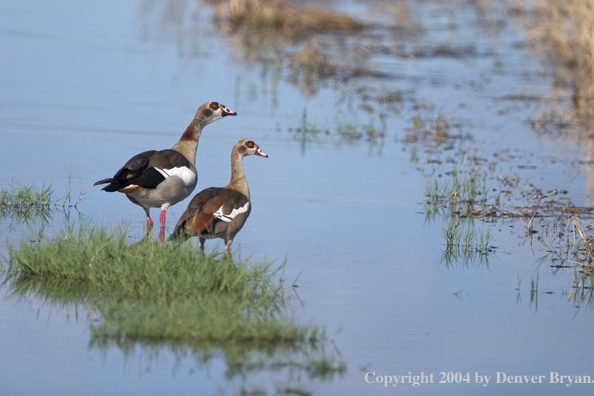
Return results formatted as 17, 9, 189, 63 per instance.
524, 0, 594, 125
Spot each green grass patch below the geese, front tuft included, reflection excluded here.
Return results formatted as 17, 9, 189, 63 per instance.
6, 227, 319, 343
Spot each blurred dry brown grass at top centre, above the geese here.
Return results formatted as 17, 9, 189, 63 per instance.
202, 0, 368, 94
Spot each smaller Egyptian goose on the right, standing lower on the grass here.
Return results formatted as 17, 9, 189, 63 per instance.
169, 139, 268, 254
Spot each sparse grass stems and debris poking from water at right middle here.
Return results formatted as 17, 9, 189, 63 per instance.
425, 158, 594, 307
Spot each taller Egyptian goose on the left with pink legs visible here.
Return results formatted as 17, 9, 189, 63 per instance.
94, 102, 237, 241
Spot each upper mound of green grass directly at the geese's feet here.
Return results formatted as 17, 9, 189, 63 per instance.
8, 227, 282, 298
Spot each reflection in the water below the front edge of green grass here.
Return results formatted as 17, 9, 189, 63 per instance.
89, 337, 346, 395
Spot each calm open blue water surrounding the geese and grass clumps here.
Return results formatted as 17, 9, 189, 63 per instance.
0, 1, 594, 395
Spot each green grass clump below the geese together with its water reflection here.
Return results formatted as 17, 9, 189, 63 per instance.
2, 226, 346, 392
